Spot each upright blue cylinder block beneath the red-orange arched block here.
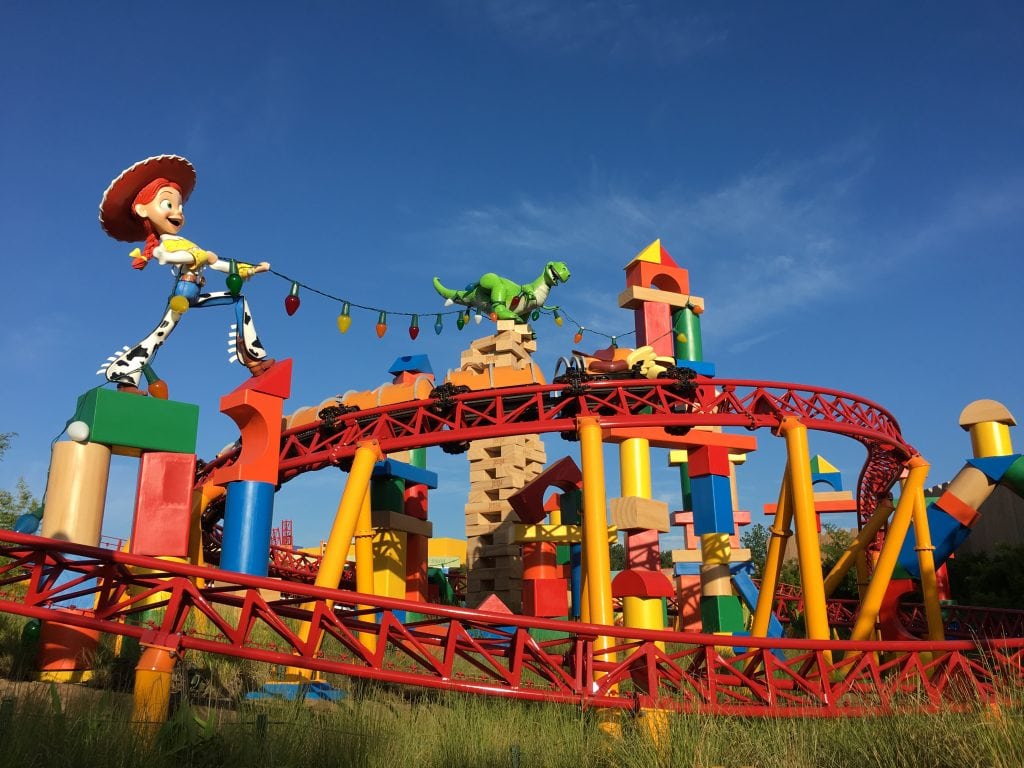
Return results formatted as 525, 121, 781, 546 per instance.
220, 480, 273, 577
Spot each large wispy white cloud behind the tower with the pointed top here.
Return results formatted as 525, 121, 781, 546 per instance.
432, 150, 870, 338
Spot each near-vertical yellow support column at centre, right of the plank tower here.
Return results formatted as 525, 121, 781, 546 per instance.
577, 416, 621, 735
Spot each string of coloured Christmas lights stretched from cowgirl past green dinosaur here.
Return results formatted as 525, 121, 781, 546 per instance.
264, 269, 636, 346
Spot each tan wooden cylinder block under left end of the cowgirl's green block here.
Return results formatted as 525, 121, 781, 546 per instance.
40, 441, 111, 547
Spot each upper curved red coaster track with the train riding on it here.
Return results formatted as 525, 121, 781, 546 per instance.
197, 378, 914, 520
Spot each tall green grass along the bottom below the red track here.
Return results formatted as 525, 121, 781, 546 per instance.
0, 681, 1024, 768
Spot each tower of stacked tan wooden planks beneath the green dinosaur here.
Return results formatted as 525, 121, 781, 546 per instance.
461, 321, 547, 612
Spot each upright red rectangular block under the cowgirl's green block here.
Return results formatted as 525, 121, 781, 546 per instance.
129, 452, 196, 557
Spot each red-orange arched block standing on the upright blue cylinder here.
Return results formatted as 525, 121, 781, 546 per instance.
211, 391, 284, 485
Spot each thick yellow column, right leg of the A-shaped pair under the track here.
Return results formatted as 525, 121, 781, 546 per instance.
780, 417, 829, 640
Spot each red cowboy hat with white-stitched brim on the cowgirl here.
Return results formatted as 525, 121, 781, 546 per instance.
99, 155, 196, 243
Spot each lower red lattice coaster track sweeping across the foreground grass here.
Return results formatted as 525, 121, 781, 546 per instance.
0, 531, 1024, 717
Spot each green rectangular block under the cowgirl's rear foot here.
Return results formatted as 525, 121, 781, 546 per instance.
75, 389, 199, 456
